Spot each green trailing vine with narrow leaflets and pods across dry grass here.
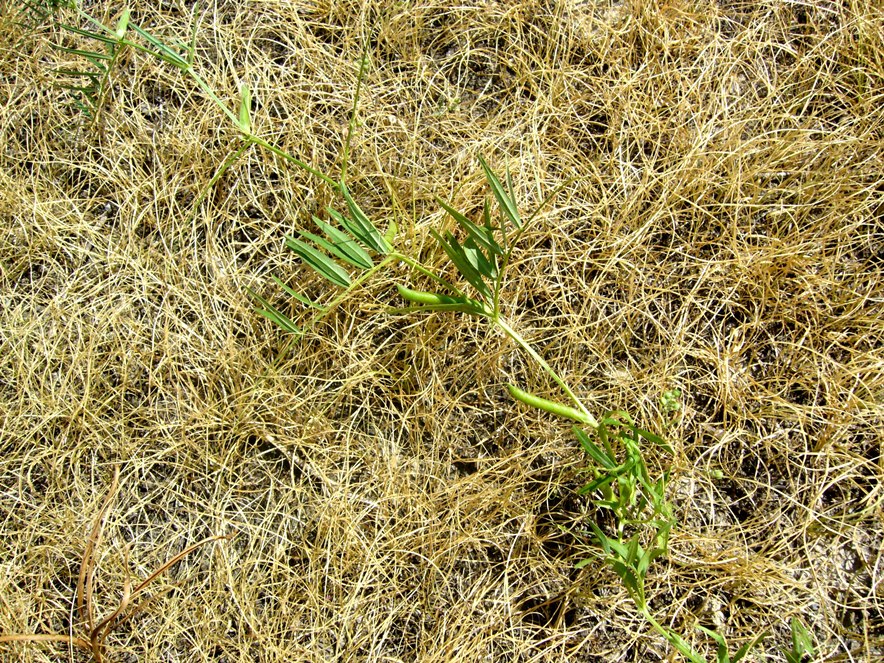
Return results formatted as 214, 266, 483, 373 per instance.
12, 6, 800, 663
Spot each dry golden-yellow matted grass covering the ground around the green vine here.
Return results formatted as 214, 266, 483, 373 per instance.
0, 0, 884, 662
